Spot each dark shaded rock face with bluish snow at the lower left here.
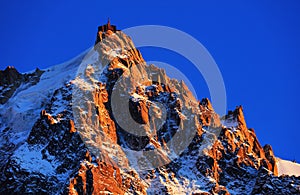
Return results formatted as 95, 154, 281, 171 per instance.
0, 85, 86, 194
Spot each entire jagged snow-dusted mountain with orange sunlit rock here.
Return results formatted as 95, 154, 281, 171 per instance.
0, 22, 300, 195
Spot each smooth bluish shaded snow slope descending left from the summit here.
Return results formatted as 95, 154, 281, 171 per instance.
0, 52, 86, 141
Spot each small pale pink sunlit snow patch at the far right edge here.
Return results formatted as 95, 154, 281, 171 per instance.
277, 158, 300, 176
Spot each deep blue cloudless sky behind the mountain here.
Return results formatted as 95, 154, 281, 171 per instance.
0, 0, 300, 162
